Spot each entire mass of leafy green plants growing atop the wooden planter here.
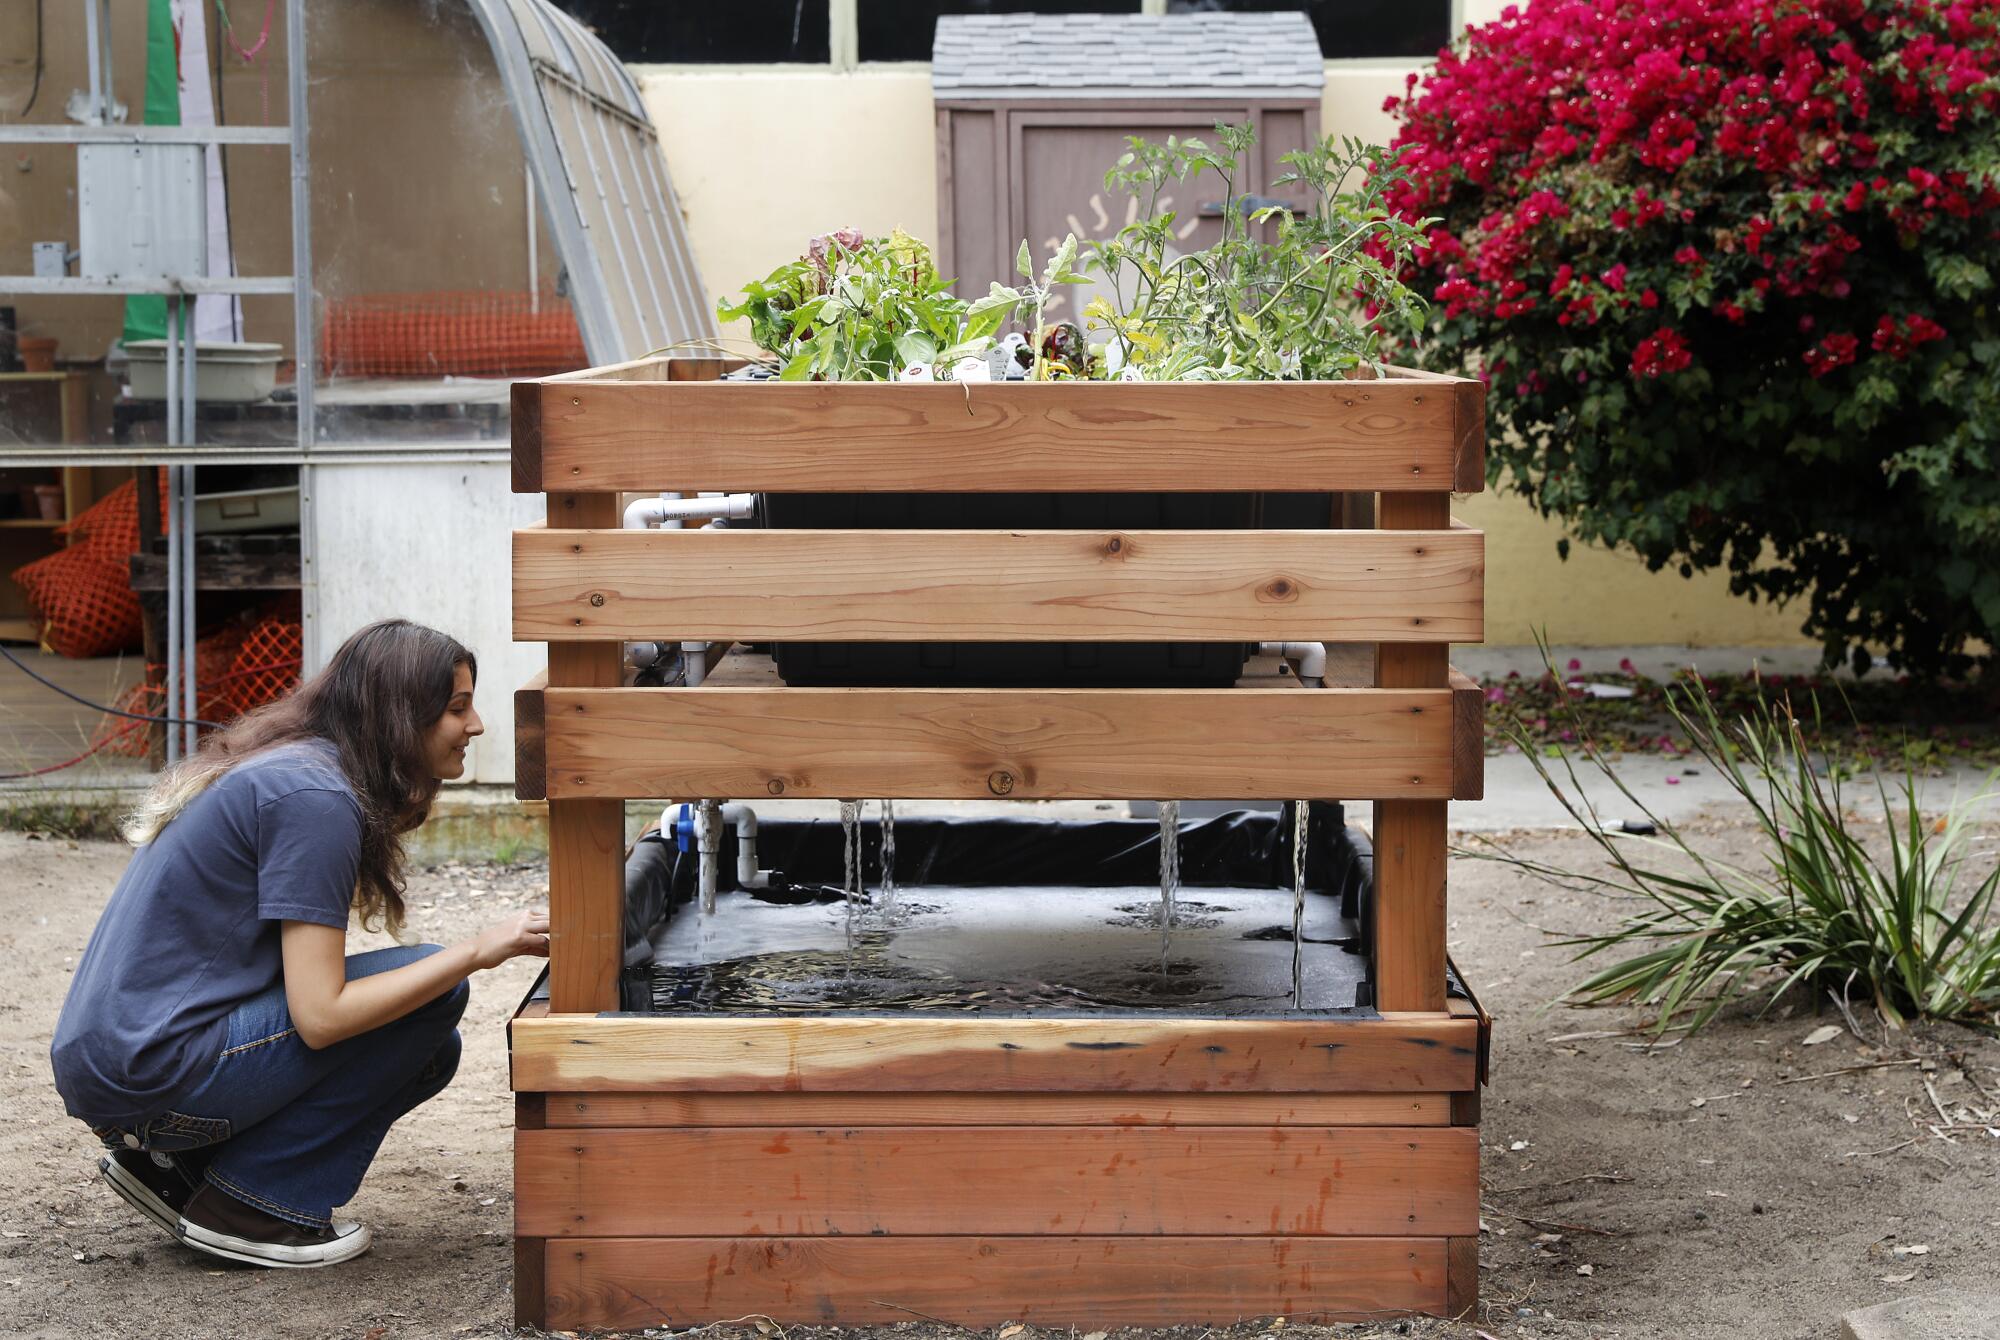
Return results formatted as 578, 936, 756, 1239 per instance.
718, 124, 1430, 382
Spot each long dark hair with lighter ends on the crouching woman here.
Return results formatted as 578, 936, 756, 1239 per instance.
120, 618, 480, 932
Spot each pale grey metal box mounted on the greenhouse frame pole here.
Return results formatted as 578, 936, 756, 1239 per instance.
76, 144, 208, 280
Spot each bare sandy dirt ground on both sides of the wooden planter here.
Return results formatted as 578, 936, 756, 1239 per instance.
0, 824, 2000, 1340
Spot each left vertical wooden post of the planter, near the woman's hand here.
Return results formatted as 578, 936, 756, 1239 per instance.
548, 494, 624, 1014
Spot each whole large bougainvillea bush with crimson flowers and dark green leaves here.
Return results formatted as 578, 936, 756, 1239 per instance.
1390, 0, 2000, 674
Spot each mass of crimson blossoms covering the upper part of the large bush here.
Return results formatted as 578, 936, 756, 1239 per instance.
1388, 0, 2000, 386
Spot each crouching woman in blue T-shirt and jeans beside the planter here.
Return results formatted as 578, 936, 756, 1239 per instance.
52, 620, 548, 1266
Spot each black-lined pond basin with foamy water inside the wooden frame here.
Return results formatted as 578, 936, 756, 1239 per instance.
576, 802, 1464, 1018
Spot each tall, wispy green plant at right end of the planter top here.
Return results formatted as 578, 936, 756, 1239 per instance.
1084, 124, 1434, 380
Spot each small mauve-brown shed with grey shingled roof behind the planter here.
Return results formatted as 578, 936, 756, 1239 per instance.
930, 12, 1326, 316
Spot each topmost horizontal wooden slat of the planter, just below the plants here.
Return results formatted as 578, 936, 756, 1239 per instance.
514, 378, 1478, 494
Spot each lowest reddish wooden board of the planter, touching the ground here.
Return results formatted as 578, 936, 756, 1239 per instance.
544, 1236, 1446, 1330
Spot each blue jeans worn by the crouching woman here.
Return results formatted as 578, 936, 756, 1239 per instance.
98, 944, 470, 1228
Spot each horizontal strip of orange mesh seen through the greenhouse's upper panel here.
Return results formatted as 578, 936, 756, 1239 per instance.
320, 292, 588, 376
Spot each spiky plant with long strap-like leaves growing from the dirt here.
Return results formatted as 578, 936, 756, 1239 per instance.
1470, 652, 2000, 1032
